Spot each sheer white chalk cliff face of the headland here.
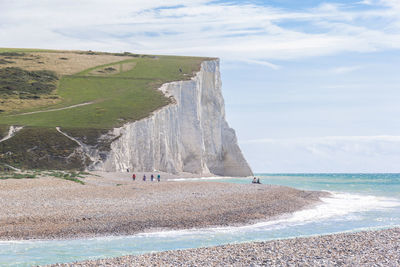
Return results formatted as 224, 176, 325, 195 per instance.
91, 60, 252, 176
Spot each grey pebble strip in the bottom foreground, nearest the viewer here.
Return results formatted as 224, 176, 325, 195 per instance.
52, 228, 400, 267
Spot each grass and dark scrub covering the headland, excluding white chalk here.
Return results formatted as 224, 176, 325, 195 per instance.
0, 48, 211, 169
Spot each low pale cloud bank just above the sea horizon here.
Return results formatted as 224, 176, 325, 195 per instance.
241, 135, 400, 172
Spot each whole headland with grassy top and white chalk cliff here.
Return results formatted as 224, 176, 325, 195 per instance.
0, 48, 252, 176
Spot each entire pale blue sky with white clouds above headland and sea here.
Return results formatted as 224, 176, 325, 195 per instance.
0, 0, 400, 173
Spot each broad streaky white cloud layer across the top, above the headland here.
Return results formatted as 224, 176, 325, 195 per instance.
0, 0, 400, 63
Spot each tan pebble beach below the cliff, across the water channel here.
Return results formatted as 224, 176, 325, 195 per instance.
0, 172, 328, 241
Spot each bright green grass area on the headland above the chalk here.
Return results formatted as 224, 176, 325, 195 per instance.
0, 54, 206, 128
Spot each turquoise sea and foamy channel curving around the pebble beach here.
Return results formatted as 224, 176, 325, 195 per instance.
0, 174, 400, 266
